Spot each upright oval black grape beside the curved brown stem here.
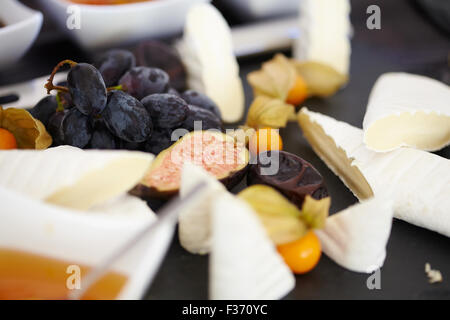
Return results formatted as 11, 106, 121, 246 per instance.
67, 63, 107, 115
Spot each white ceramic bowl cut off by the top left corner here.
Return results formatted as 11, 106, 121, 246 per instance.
0, 0, 42, 69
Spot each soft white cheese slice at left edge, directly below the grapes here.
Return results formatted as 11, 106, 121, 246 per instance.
0, 146, 153, 210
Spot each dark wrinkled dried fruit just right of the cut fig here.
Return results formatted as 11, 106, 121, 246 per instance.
247, 151, 328, 209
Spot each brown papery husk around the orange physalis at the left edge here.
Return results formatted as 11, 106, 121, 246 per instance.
0, 106, 52, 150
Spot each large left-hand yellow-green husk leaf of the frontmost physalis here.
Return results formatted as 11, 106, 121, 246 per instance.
238, 185, 307, 245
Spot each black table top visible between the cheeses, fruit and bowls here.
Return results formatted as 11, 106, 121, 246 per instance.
0, 0, 450, 299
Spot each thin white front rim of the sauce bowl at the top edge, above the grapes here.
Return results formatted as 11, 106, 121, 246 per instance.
51, 0, 200, 12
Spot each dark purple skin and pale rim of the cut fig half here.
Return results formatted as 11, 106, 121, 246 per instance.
130, 131, 249, 200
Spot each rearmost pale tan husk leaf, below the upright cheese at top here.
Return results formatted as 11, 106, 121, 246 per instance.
293, 60, 348, 97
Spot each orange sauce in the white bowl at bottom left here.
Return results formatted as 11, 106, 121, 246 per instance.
0, 248, 127, 300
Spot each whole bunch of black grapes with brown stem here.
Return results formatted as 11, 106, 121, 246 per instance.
30, 42, 222, 154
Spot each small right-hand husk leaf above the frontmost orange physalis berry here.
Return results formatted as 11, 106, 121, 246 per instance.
300, 195, 331, 229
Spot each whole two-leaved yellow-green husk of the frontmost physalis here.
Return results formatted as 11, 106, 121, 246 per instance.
238, 185, 330, 245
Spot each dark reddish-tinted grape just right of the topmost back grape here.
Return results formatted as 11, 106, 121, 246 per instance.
119, 67, 169, 100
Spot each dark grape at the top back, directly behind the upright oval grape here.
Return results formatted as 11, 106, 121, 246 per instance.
94, 49, 136, 87
